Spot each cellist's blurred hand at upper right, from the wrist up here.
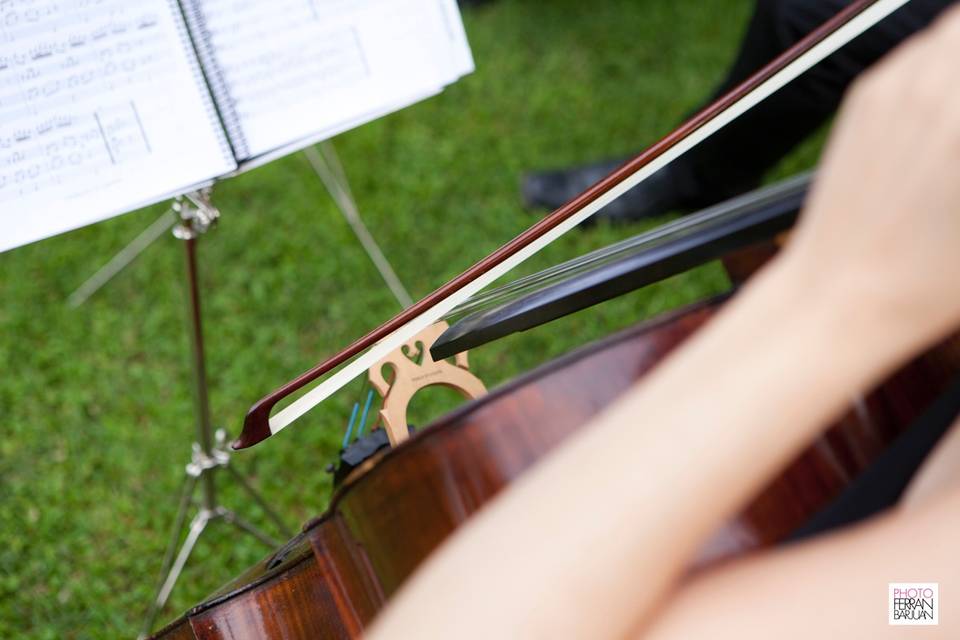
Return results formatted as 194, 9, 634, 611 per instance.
784, 2, 960, 354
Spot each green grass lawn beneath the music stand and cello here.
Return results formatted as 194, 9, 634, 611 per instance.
0, 0, 817, 638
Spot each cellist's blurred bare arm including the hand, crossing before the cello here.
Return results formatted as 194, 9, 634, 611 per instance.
371, 6, 960, 639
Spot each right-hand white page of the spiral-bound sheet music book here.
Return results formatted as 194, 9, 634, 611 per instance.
187, 0, 472, 160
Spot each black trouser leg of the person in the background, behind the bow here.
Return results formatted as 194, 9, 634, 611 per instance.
677, 0, 951, 205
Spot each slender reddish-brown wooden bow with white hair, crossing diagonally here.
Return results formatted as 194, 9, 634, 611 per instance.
233, 0, 910, 449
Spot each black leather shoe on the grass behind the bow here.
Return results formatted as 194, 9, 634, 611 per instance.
520, 160, 701, 227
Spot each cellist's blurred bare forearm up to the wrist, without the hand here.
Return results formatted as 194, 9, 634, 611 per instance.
375, 252, 908, 638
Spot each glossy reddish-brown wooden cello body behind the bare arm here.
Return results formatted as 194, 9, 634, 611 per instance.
155, 300, 960, 640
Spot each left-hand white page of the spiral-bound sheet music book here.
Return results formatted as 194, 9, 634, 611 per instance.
0, 0, 236, 251
